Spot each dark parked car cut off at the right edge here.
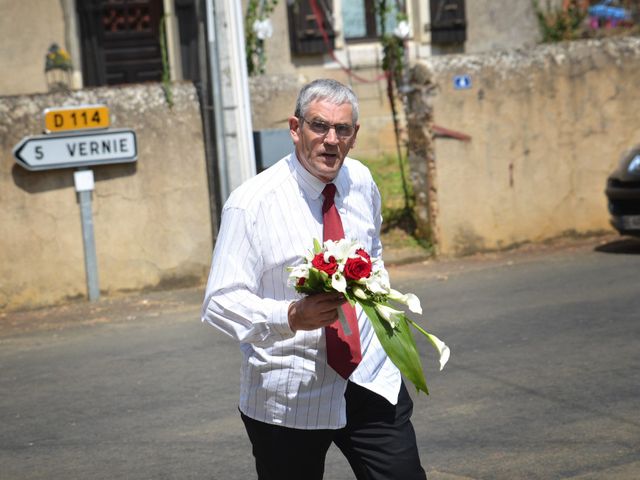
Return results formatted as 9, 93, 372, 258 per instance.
606, 145, 640, 236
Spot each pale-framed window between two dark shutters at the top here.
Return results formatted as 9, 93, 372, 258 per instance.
341, 0, 397, 42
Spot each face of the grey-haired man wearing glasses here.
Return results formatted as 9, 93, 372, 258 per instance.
289, 100, 360, 183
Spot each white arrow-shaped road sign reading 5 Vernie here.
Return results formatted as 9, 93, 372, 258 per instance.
13, 129, 138, 170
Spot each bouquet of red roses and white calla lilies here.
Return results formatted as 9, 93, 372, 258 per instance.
289, 239, 450, 394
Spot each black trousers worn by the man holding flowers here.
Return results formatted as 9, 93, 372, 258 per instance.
241, 382, 427, 480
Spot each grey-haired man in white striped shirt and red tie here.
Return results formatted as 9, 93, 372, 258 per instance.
202, 79, 426, 480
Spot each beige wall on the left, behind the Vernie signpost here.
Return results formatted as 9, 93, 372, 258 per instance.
0, 84, 212, 309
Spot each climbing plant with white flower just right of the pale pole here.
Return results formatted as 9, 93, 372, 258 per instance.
244, 0, 278, 76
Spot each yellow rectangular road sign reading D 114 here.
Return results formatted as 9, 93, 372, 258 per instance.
44, 105, 111, 133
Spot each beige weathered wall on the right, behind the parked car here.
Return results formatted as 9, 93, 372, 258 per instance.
412, 37, 640, 255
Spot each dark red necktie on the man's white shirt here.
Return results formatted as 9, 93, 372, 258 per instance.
322, 183, 362, 379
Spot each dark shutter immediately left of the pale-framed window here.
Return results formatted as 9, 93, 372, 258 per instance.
287, 0, 335, 55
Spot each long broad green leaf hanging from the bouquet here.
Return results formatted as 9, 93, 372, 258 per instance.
356, 299, 429, 395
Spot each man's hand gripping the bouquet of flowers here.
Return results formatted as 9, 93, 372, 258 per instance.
289, 292, 346, 332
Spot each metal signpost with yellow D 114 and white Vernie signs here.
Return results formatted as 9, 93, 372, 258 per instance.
13, 105, 138, 302
